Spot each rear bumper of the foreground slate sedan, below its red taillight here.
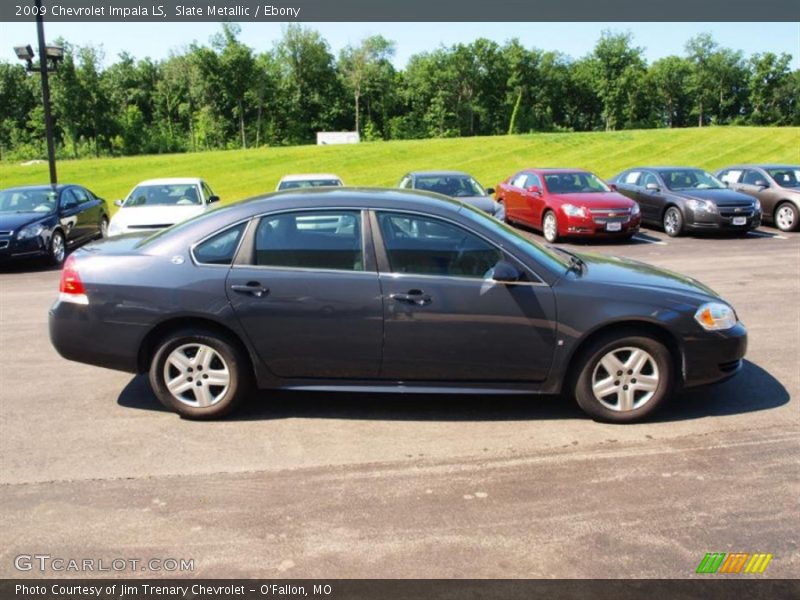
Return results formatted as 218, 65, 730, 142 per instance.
49, 300, 144, 373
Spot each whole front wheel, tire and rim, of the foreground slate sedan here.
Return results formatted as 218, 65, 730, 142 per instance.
575, 335, 674, 423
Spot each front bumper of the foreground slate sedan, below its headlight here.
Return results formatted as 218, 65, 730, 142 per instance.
683, 323, 747, 387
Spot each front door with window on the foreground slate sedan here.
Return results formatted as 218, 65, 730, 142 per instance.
376, 212, 555, 382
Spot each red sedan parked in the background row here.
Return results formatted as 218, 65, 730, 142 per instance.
495, 169, 642, 243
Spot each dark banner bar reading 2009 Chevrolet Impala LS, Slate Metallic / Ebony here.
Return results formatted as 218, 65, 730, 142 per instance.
0, 0, 798, 22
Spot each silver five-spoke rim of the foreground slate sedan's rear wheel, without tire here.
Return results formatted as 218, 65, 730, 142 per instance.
163, 343, 231, 408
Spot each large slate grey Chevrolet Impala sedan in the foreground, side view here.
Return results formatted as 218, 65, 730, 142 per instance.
50, 188, 747, 422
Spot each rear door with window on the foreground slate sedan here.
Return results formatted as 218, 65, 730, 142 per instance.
226, 209, 383, 379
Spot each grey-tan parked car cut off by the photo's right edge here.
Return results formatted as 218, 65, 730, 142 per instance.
717, 165, 800, 231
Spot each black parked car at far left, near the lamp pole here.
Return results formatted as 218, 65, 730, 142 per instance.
0, 184, 108, 264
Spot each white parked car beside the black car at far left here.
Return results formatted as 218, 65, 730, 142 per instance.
108, 177, 219, 235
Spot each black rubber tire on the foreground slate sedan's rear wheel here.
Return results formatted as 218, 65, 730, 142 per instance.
149, 329, 252, 419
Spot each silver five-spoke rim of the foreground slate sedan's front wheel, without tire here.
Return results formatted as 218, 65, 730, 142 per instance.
592, 346, 660, 412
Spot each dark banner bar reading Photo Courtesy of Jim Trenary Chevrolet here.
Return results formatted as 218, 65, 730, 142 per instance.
0, 575, 800, 600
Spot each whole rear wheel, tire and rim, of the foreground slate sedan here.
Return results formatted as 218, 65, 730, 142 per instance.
150, 329, 250, 419
